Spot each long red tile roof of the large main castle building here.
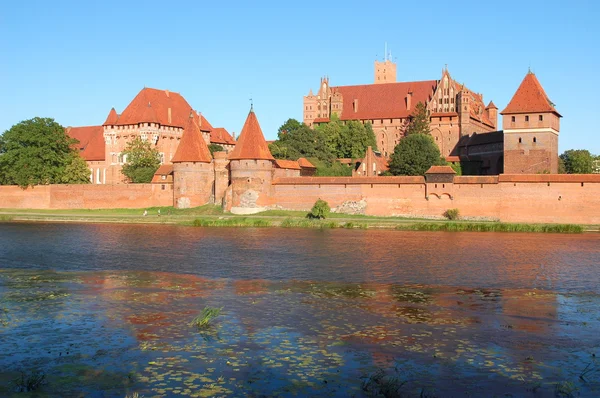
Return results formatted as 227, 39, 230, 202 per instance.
331, 80, 437, 120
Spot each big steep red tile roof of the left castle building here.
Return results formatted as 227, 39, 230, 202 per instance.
116, 88, 199, 128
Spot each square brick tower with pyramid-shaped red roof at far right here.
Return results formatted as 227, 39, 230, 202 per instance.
500, 71, 562, 174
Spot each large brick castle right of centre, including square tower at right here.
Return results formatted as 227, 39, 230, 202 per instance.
303, 58, 561, 175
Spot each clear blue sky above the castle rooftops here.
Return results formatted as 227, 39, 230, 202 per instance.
0, 0, 600, 154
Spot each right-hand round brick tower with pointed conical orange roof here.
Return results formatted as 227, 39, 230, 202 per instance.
229, 108, 275, 214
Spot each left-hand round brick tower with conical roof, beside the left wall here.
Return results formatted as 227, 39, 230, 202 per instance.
171, 110, 215, 209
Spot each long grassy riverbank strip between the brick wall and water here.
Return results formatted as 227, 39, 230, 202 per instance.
0, 205, 599, 233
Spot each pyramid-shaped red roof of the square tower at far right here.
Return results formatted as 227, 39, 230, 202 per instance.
500, 72, 561, 117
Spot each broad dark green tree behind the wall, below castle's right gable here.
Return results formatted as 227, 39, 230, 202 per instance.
389, 134, 445, 176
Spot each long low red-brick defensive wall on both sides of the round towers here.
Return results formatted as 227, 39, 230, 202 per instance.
0, 174, 600, 224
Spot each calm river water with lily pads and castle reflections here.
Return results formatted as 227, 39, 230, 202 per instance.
0, 224, 600, 397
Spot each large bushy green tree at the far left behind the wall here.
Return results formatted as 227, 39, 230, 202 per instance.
0, 117, 89, 188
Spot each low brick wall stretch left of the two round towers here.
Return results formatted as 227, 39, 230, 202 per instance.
0, 184, 173, 209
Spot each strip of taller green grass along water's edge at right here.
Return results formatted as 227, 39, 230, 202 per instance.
396, 222, 583, 234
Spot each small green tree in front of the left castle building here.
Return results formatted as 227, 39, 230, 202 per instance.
122, 137, 160, 183
